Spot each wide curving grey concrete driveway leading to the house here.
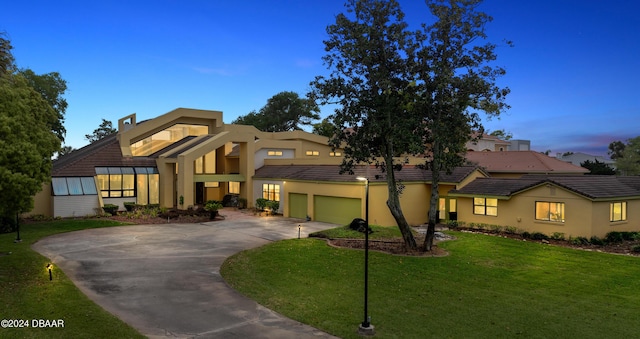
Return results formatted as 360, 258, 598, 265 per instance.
33, 210, 336, 338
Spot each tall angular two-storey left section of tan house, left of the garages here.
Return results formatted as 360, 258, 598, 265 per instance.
30, 108, 341, 217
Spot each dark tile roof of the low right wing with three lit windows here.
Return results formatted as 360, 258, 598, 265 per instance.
449, 175, 640, 199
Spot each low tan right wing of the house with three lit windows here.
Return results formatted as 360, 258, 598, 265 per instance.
449, 175, 640, 238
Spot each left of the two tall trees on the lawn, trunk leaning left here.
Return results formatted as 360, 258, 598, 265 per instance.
311, 0, 424, 249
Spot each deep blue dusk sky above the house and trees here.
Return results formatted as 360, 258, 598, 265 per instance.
0, 0, 640, 155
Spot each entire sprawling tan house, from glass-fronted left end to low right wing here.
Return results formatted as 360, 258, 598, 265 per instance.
30, 108, 640, 236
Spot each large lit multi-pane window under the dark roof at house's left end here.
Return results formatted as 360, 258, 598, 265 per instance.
96, 167, 160, 205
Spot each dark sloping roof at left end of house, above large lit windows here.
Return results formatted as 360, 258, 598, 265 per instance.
51, 134, 156, 177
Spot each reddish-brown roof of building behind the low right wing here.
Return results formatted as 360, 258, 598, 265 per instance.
466, 151, 589, 174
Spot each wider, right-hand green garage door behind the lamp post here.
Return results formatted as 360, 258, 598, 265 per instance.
313, 195, 362, 225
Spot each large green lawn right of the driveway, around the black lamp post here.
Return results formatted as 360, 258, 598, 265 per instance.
221, 230, 640, 338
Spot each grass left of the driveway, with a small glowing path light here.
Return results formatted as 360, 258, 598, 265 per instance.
0, 219, 143, 338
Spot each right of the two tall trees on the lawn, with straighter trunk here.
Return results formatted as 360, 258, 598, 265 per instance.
416, 0, 510, 250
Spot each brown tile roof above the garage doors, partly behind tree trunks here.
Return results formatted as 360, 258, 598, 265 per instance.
253, 165, 477, 183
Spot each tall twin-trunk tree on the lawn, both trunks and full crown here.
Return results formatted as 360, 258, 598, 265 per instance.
312, 0, 509, 250
